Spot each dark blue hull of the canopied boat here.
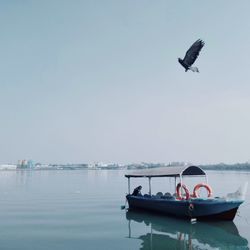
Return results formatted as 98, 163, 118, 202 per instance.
126, 195, 243, 220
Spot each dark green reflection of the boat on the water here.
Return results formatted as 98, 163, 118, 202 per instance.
126, 211, 249, 250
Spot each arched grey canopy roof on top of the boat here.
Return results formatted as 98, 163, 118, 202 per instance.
125, 166, 206, 178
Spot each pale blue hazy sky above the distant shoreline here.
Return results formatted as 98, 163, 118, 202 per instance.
0, 0, 250, 164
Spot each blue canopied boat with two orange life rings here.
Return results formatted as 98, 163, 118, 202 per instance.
125, 165, 247, 221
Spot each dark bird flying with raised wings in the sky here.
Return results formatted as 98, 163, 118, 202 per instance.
178, 39, 205, 72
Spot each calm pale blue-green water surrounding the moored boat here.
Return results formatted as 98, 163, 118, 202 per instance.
0, 170, 250, 250
